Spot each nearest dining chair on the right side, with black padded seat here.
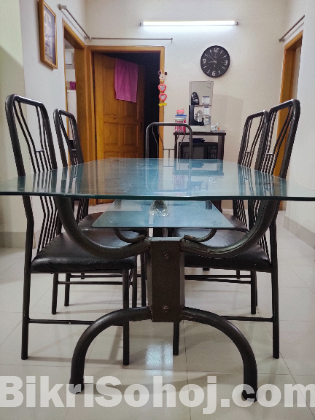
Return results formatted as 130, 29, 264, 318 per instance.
174, 99, 300, 359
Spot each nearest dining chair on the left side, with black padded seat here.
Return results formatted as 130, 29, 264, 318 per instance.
6, 94, 143, 364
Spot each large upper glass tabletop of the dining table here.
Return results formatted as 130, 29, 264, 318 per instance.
0, 158, 315, 201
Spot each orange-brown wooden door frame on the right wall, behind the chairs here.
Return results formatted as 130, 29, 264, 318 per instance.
274, 31, 303, 176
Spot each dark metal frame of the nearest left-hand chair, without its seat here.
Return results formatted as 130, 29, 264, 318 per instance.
6, 94, 138, 364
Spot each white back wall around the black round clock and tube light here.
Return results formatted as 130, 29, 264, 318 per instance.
86, 0, 287, 161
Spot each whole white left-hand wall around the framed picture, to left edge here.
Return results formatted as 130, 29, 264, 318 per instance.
0, 0, 85, 247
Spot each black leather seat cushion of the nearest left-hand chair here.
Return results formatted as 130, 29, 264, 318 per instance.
31, 229, 137, 273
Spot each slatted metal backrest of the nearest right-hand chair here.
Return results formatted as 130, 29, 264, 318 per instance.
249, 99, 301, 253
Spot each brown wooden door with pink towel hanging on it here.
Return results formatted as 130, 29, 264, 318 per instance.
94, 54, 144, 159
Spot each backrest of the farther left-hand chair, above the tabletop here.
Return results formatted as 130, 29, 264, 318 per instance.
54, 109, 84, 167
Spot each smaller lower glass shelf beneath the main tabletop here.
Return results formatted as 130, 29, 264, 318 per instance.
93, 200, 234, 229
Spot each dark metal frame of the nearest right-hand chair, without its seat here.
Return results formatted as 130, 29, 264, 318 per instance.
177, 99, 300, 359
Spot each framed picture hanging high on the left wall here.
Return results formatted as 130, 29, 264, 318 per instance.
38, 0, 58, 69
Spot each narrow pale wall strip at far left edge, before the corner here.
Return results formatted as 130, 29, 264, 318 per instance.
0, 0, 26, 246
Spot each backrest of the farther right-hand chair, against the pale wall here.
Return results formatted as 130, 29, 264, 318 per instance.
233, 111, 268, 226
